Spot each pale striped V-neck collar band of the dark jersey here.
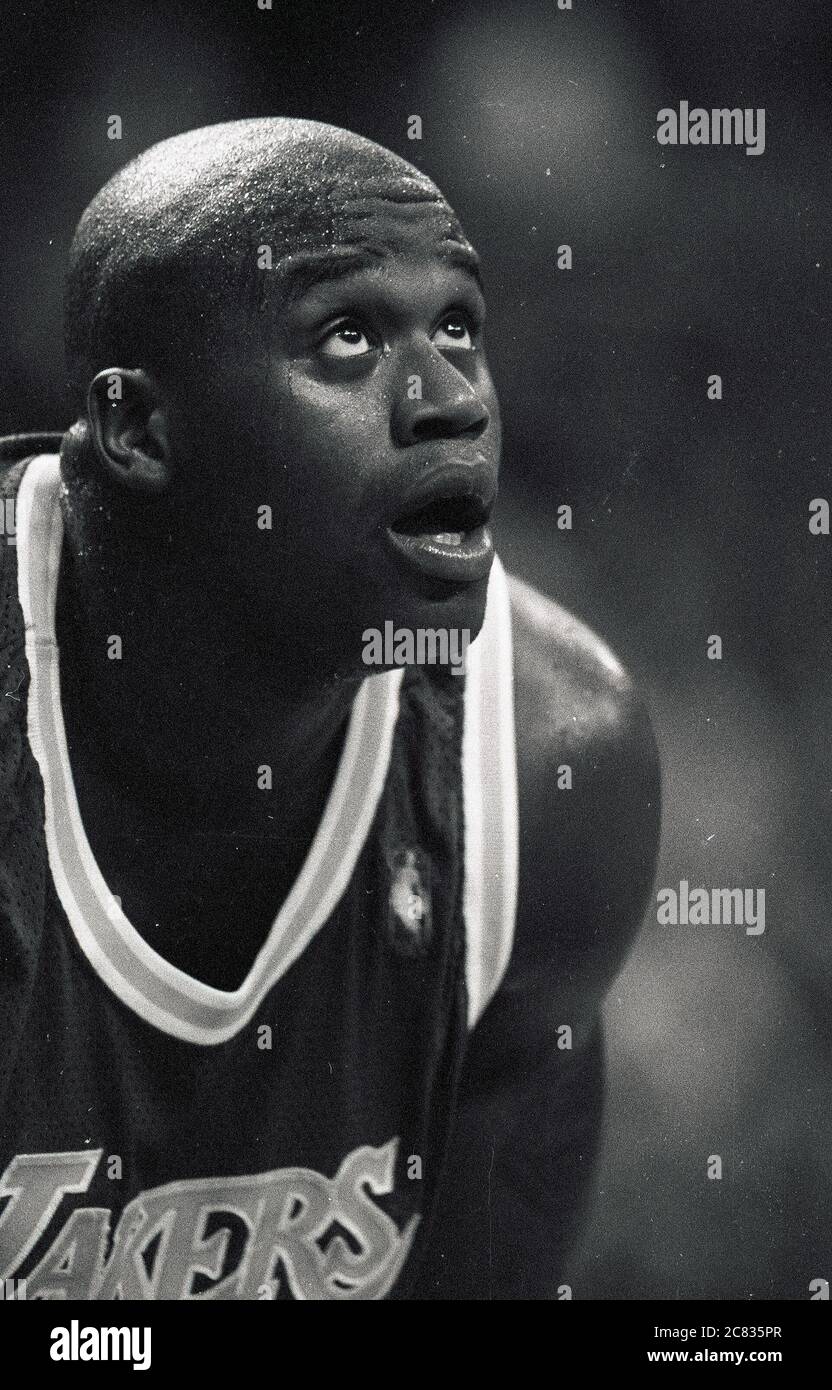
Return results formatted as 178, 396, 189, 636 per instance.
17, 455, 404, 1045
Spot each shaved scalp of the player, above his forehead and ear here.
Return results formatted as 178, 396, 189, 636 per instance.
65, 117, 476, 410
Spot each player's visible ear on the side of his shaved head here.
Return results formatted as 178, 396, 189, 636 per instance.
86, 367, 172, 496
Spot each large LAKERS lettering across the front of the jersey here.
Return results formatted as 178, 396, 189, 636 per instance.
0, 1138, 419, 1300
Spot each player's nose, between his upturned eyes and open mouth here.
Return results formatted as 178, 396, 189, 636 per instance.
392, 348, 490, 445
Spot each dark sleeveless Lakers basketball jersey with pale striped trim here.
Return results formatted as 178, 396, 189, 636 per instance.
0, 455, 517, 1300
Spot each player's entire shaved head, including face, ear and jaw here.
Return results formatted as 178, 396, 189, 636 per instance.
61, 118, 500, 685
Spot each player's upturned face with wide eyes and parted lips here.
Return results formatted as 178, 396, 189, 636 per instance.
174, 199, 500, 686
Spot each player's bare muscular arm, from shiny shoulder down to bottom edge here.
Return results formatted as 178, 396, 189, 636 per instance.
421, 581, 658, 1298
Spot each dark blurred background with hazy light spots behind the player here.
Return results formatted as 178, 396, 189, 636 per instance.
0, 0, 832, 1298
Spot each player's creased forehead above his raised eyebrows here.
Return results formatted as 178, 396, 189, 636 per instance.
275, 196, 479, 304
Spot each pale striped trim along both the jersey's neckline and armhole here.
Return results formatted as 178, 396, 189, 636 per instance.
17, 455, 517, 1045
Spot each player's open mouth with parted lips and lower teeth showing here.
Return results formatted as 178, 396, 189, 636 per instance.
388, 492, 494, 584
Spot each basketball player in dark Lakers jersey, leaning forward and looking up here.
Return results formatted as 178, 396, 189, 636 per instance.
0, 120, 658, 1300
